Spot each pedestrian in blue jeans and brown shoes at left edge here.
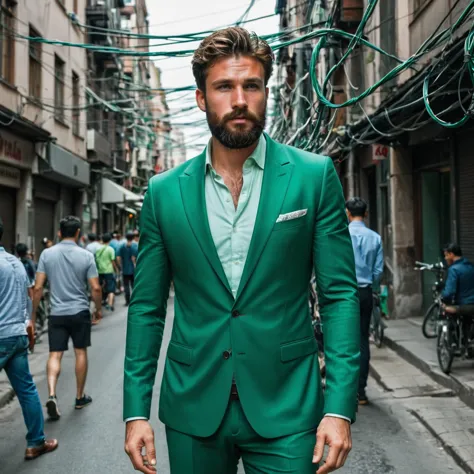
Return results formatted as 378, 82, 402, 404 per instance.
0, 219, 58, 460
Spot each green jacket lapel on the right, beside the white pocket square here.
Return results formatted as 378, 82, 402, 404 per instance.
235, 134, 293, 302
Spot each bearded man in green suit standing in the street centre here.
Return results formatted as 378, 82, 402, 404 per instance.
124, 27, 360, 474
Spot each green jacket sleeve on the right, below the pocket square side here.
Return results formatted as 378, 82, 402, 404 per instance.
313, 158, 360, 422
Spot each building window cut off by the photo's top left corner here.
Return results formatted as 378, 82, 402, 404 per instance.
0, 0, 15, 84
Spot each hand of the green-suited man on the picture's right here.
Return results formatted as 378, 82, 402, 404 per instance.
313, 416, 352, 474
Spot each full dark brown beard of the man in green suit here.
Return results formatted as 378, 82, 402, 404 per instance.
206, 104, 267, 150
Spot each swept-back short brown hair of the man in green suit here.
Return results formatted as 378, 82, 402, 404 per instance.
192, 26, 274, 91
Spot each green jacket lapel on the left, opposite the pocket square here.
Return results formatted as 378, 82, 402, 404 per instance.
179, 151, 232, 294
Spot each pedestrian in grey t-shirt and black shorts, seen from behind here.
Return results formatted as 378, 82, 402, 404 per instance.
33, 216, 102, 420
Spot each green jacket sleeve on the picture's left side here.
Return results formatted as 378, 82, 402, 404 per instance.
123, 181, 171, 420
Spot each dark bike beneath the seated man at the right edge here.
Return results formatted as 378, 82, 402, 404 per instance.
436, 305, 474, 375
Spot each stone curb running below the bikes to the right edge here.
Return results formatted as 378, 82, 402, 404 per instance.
384, 334, 474, 412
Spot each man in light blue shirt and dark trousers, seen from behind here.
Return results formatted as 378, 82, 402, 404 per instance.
346, 197, 383, 405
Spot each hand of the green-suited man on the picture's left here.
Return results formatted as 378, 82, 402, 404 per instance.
125, 420, 156, 474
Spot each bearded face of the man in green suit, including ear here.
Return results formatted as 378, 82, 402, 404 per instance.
196, 56, 268, 149
